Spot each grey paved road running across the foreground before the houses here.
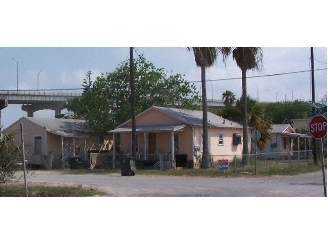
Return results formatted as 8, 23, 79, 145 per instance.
16, 171, 324, 197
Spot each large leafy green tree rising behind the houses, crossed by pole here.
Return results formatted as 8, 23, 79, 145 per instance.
68, 55, 200, 133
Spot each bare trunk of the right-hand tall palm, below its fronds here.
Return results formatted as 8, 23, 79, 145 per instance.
241, 69, 249, 165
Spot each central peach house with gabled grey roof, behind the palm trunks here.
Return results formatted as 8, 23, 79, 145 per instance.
110, 106, 251, 168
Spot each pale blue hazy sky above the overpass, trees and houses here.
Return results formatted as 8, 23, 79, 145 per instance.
0, 47, 327, 128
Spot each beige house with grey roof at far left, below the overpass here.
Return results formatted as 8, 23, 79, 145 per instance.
3, 117, 112, 168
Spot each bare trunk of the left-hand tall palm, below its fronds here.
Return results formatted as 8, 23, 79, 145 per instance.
201, 66, 210, 168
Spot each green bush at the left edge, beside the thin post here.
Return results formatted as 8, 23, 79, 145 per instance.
0, 134, 21, 183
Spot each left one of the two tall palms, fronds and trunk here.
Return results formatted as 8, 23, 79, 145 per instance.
188, 47, 231, 168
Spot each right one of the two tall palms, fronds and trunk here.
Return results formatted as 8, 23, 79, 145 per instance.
232, 47, 263, 164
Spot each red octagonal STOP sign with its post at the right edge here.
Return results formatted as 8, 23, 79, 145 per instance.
309, 115, 327, 197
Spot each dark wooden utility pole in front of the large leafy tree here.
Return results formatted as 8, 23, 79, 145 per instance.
130, 47, 136, 170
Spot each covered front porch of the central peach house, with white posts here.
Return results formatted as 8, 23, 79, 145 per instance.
111, 125, 193, 170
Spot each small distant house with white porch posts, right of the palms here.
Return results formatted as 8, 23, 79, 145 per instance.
252, 124, 311, 158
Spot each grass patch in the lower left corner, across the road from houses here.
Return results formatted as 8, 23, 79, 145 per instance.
0, 182, 107, 197
